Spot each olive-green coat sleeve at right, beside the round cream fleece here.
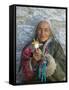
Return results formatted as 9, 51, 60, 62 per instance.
49, 43, 66, 81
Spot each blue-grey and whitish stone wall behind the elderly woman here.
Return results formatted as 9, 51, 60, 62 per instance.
16, 6, 66, 82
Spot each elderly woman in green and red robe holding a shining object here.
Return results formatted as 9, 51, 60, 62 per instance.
19, 21, 66, 82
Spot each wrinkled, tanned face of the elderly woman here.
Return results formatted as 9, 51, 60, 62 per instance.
37, 22, 51, 42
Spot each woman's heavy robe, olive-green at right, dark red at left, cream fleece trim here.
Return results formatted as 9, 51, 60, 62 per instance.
20, 38, 66, 82
